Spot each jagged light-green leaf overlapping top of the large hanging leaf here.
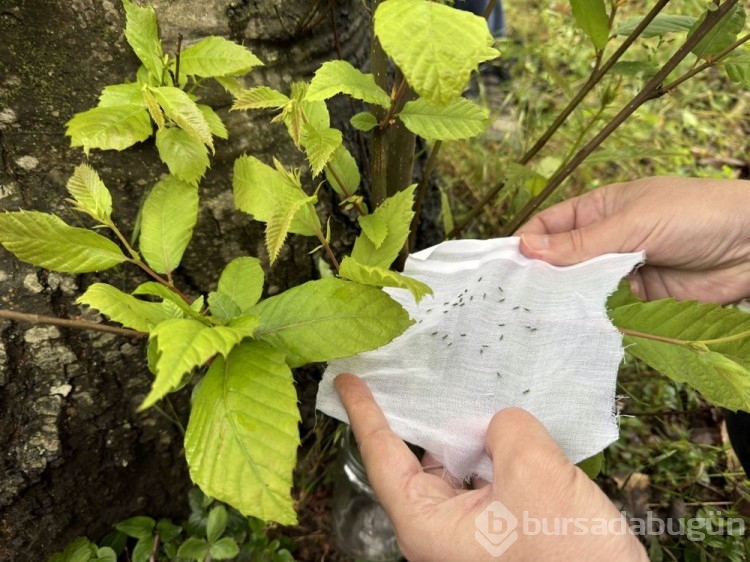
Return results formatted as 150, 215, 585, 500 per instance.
139, 318, 245, 410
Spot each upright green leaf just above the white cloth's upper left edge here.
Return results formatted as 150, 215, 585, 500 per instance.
352, 185, 416, 268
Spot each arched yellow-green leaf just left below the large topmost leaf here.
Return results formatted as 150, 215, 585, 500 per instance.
305, 60, 391, 109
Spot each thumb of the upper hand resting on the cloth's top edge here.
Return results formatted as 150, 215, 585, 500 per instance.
519, 220, 630, 265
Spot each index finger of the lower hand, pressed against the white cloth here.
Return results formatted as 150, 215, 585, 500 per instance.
334, 374, 422, 519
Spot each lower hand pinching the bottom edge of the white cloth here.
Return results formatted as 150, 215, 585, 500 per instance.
335, 375, 648, 562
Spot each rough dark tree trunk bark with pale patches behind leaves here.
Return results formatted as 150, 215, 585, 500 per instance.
0, 0, 368, 562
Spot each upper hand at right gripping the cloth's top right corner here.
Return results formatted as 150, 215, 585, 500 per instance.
516, 177, 750, 304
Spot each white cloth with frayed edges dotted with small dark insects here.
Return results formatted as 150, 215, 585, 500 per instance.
317, 238, 644, 480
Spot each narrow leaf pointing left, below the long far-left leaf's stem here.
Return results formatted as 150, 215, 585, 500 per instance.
76, 283, 170, 332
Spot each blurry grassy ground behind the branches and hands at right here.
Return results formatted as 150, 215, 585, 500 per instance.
439, 0, 750, 561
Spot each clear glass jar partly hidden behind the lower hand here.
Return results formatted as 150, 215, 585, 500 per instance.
333, 427, 401, 562
